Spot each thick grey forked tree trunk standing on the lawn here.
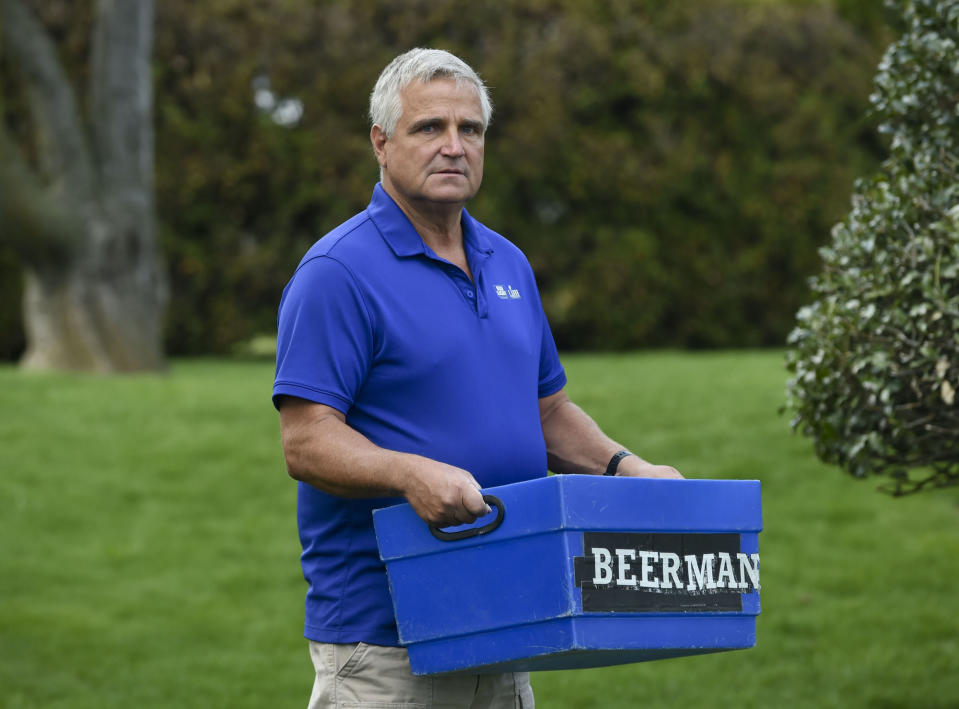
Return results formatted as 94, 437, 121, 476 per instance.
0, 0, 167, 372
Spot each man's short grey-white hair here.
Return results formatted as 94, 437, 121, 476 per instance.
370, 47, 493, 138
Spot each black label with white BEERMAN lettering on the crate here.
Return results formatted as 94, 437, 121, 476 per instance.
573, 532, 759, 613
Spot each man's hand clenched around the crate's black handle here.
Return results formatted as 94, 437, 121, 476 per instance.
402, 456, 491, 527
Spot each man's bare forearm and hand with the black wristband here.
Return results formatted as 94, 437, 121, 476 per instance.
539, 390, 683, 478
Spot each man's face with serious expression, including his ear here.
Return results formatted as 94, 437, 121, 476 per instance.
370, 79, 485, 205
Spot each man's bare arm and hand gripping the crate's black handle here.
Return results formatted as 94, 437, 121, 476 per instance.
280, 396, 490, 526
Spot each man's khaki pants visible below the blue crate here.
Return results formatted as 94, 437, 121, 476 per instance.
309, 641, 534, 709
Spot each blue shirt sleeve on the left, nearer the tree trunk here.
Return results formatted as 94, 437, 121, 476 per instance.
273, 256, 373, 414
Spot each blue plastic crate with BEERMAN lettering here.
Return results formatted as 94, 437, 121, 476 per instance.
373, 475, 762, 674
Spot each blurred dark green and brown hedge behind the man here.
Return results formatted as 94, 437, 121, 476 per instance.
0, 0, 889, 358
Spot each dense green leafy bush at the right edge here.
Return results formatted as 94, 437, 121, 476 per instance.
787, 0, 959, 494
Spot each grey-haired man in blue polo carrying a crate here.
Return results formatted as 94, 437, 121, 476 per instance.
273, 49, 682, 707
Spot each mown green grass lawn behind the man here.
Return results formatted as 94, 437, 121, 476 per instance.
0, 352, 959, 709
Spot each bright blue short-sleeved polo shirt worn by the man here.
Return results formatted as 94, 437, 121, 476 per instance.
273, 185, 566, 645
